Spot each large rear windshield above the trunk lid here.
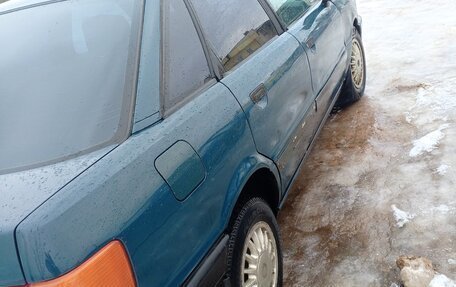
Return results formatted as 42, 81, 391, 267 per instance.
0, 0, 141, 173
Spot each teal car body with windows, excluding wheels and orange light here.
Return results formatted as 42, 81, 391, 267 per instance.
0, 0, 365, 286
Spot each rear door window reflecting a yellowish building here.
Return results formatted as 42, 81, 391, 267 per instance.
191, 0, 277, 71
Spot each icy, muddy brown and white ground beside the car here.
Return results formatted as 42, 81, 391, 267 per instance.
279, 0, 456, 287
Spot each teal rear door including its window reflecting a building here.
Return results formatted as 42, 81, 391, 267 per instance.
190, 0, 315, 187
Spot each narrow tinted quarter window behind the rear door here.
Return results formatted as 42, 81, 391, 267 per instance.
162, 0, 211, 111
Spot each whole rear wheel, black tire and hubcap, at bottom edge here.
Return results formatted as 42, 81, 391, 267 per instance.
228, 198, 283, 287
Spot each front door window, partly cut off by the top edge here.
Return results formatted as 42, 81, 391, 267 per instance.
268, 0, 316, 27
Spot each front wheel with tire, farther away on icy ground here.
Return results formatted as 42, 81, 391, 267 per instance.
335, 27, 366, 108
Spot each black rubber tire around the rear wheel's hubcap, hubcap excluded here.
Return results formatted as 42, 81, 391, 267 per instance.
228, 198, 283, 287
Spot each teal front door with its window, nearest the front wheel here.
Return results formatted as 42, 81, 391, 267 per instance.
276, 0, 346, 120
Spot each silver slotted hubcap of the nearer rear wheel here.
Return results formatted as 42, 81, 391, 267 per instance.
241, 221, 278, 287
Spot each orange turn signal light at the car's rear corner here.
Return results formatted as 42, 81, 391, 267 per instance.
28, 241, 136, 287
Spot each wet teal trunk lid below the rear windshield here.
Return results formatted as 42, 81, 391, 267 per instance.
0, 146, 114, 287
